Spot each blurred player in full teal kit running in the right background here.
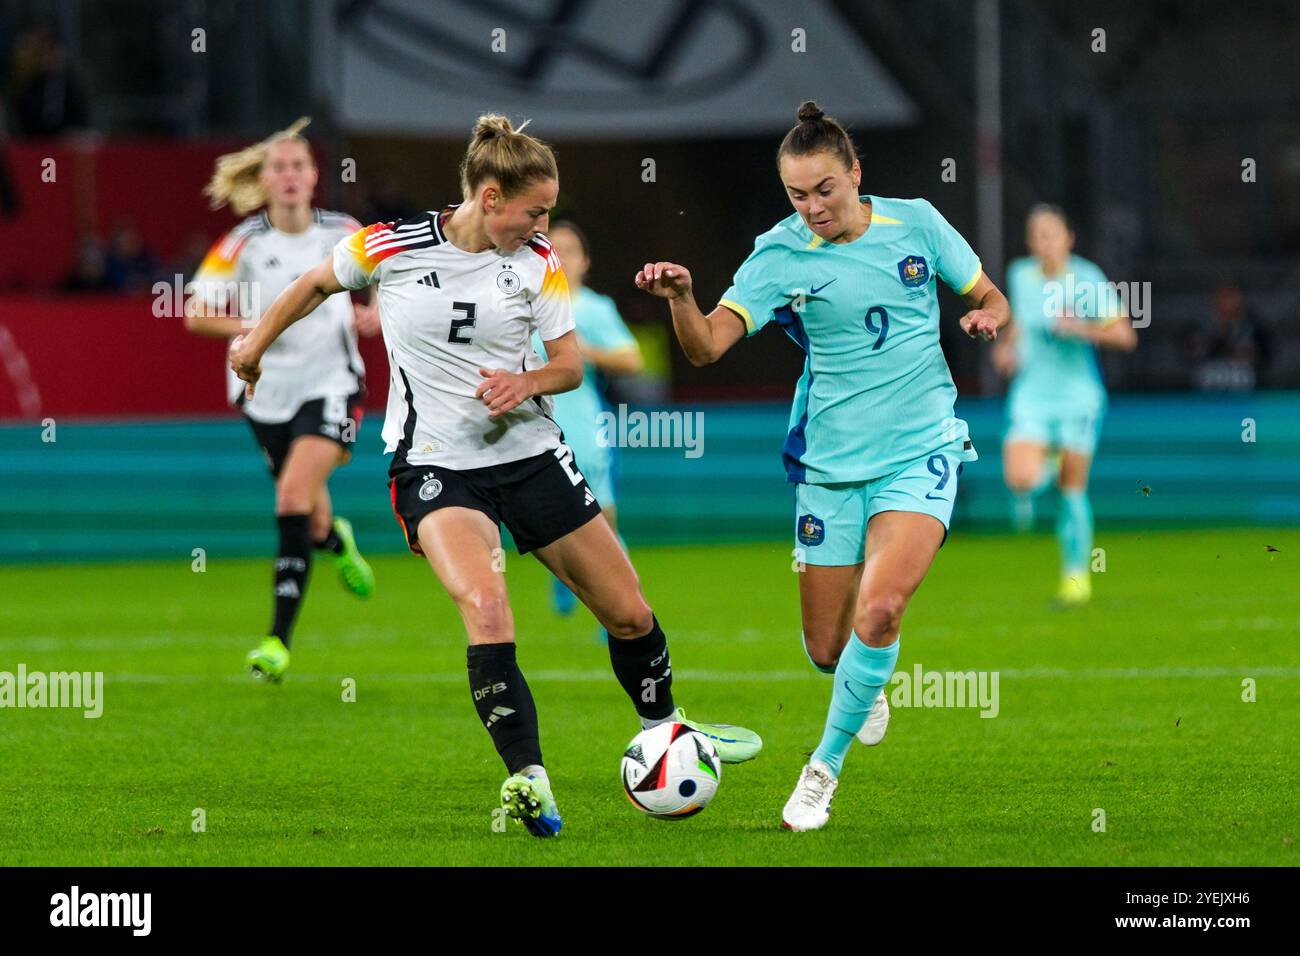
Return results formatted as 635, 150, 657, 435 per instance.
993, 203, 1138, 606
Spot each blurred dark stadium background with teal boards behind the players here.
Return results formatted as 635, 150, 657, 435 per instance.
0, 0, 1300, 562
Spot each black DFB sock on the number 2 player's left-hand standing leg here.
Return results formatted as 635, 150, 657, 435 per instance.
465, 644, 542, 774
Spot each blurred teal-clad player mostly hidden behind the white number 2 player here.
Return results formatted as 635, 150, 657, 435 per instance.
533, 220, 645, 614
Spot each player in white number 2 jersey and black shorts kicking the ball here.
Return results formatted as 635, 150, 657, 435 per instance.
230, 116, 761, 836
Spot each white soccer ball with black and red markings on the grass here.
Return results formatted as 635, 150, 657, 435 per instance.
620, 723, 723, 819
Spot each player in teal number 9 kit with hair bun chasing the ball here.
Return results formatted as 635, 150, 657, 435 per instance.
636, 103, 1010, 830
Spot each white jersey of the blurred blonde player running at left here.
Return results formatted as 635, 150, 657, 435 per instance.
194, 209, 365, 423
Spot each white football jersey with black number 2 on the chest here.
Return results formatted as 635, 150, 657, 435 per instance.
334, 207, 573, 470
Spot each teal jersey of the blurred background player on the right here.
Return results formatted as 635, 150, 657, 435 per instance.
1006, 255, 1121, 412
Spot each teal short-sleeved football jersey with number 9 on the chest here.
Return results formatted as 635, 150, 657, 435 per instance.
720, 196, 982, 484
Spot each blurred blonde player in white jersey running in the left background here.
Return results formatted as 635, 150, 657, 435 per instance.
185, 118, 378, 682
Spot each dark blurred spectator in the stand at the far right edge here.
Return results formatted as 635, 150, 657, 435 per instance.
1190, 278, 1273, 392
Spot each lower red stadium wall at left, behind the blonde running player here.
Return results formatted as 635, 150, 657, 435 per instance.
0, 295, 389, 420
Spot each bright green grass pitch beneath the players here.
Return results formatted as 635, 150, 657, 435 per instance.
0, 528, 1300, 865
